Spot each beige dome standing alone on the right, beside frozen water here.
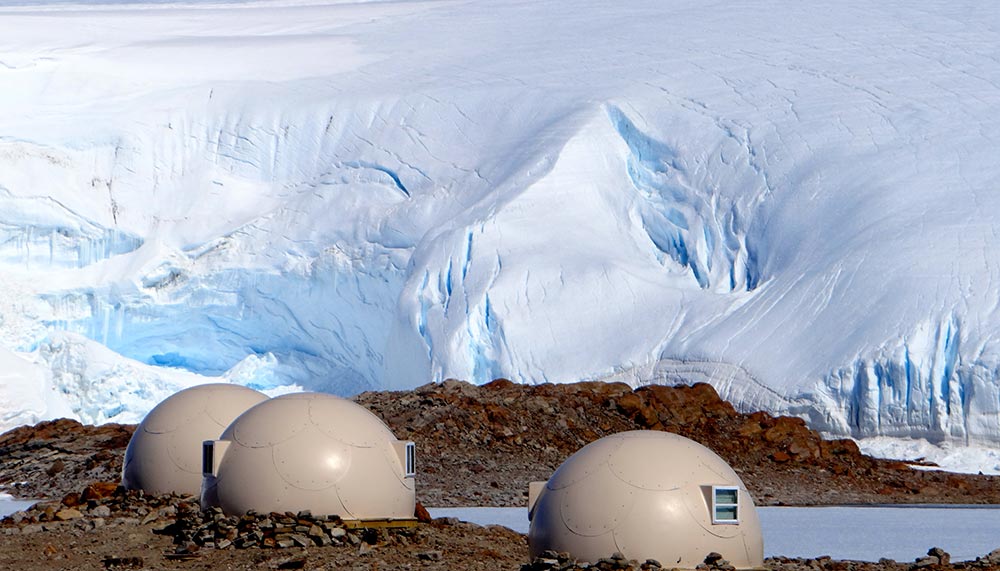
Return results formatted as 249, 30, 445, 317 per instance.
528, 430, 764, 569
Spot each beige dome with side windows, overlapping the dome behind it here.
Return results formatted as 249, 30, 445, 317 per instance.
201, 393, 415, 520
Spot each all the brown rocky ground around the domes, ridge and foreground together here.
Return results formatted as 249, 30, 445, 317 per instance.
0, 380, 1000, 571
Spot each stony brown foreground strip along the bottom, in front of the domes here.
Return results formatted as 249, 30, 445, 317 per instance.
0, 483, 1000, 571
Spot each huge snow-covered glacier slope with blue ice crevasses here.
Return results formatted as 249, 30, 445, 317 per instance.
0, 0, 1000, 470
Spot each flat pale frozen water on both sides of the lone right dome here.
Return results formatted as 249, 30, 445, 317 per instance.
429, 506, 1000, 561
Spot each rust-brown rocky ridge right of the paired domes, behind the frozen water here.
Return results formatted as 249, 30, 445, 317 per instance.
356, 380, 1000, 506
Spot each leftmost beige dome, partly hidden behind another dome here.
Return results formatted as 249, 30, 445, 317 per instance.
122, 384, 267, 496
